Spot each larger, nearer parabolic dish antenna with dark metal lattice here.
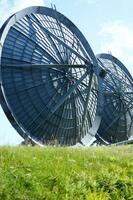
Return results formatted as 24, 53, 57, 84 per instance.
0, 7, 98, 145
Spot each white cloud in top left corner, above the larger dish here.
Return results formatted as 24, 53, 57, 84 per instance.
0, 0, 44, 26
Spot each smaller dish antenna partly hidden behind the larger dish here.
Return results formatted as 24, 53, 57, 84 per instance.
97, 54, 133, 143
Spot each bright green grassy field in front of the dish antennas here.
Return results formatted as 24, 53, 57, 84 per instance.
0, 146, 133, 200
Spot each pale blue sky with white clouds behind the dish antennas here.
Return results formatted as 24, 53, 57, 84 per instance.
0, 0, 133, 145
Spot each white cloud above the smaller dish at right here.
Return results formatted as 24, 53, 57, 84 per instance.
98, 21, 133, 75
